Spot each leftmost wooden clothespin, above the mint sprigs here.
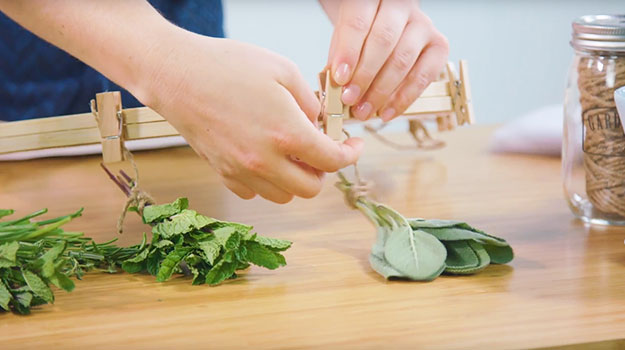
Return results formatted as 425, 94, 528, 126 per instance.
91, 91, 126, 164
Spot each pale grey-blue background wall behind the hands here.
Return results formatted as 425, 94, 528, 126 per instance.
224, 0, 625, 123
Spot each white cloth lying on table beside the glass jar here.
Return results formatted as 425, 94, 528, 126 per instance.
489, 105, 564, 157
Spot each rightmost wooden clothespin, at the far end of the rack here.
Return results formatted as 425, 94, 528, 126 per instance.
447, 60, 475, 125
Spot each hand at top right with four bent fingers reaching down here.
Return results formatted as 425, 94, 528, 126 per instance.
320, 0, 449, 121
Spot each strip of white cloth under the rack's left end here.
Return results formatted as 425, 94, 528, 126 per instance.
0, 136, 187, 161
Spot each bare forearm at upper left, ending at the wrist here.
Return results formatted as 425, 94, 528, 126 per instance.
0, 0, 178, 103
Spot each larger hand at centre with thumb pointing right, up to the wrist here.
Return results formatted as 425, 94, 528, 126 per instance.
131, 30, 363, 203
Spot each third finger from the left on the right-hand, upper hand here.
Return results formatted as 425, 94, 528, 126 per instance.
355, 21, 430, 121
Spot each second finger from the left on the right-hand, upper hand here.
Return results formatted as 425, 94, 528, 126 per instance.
342, 0, 410, 120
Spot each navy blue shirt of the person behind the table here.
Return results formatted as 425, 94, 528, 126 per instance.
0, 0, 224, 121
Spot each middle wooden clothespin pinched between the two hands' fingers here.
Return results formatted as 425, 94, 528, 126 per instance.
319, 69, 349, 141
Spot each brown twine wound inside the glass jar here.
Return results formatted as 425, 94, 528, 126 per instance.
578, 56, 625, 216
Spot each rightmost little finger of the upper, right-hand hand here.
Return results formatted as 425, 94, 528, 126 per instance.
381, 34, 449, 121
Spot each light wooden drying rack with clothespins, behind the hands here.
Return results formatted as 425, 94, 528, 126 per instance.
0, 61, 473, 163
